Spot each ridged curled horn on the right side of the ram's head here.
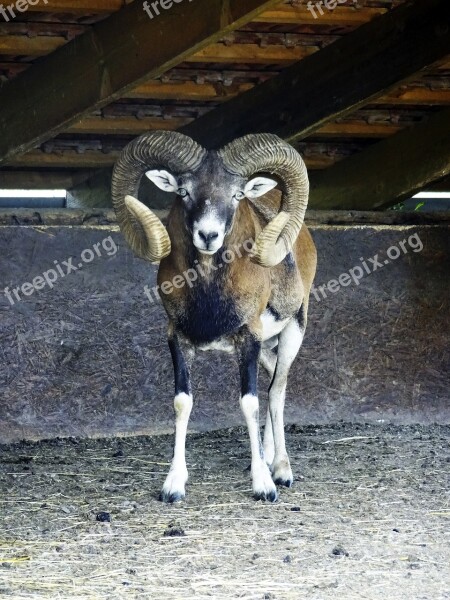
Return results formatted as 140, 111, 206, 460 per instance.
219, 133, 309, 267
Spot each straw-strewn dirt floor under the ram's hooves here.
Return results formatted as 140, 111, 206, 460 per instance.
0, 424, 450, 600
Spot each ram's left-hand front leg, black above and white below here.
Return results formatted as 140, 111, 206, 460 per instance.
159, 330, 192, 502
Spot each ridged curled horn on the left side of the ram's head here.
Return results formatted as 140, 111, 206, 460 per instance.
112, 131, 206, 262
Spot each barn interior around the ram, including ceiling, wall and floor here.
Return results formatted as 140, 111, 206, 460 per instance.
0, 0, 450, 600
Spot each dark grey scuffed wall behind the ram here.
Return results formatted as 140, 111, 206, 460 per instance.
0, 211, 450, 442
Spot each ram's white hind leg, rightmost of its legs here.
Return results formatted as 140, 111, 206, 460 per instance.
269, 318, 304, 487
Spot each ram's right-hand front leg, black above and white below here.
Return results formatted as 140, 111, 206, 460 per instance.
236, 328, 277, 502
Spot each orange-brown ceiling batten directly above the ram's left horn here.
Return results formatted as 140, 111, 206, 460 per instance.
68, 117, 192, 135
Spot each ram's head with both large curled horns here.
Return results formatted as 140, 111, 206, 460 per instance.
112, 131, 309, 266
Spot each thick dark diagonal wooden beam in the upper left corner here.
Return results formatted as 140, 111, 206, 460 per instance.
0, 0, 279, 164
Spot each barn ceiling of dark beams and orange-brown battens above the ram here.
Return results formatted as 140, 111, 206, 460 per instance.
0, 0, 450, 208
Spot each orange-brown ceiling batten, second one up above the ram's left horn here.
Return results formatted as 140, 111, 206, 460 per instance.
124, 81, 253, 102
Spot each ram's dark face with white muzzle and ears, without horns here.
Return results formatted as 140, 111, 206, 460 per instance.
147, 152, 277, 254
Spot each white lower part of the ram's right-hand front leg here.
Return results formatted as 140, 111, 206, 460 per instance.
241, 394, 277, 502
